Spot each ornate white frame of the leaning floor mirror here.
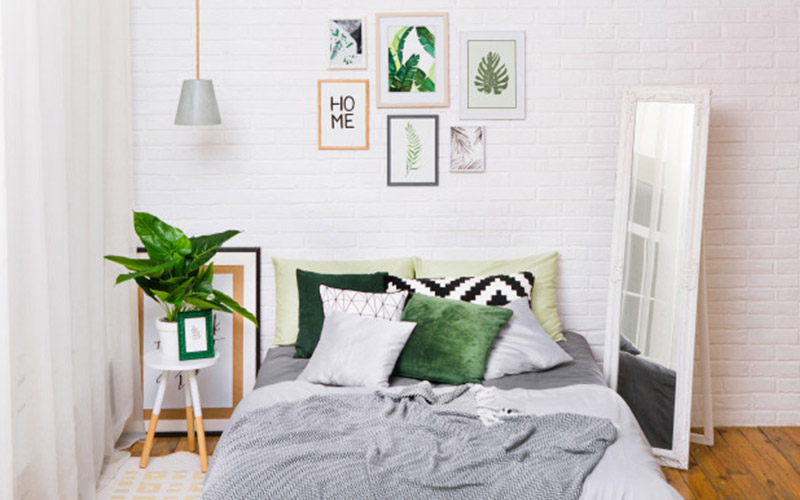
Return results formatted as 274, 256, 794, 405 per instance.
603, 88, 713, 469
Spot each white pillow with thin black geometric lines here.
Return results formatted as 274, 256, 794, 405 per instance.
319, 285, 408, 321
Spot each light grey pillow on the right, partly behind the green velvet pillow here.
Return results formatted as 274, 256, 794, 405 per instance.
483, 299, 572, 380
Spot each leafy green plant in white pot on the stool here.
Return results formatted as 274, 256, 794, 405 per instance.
105, 212, 258, 360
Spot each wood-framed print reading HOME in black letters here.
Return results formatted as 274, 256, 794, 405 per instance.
317, 80, 369, 149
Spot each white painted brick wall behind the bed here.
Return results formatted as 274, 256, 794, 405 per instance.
132, 0, 800, 425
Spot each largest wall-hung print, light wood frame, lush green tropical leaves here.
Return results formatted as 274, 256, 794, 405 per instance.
375, 13, 450, 108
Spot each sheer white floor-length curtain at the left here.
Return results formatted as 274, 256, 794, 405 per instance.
0, 0, 138, 500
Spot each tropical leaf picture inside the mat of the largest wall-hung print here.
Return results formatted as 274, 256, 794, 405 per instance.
388, 26, 436, 92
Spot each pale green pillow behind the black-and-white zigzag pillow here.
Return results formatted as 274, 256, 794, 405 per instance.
414, 252, 565, 342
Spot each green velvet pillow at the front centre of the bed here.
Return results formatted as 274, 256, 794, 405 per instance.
394, 293, 513, 385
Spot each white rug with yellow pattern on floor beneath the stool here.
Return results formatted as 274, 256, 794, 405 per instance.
97, 451, 204, 500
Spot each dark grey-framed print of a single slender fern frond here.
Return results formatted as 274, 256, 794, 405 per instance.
386, 115, 439, 186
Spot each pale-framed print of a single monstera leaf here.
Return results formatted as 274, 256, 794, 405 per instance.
459, 31, 525, 120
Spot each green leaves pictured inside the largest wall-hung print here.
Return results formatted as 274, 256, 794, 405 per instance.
388, 26, 436, 92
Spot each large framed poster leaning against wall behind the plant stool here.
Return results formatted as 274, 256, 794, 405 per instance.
138, 247, 261, 432
